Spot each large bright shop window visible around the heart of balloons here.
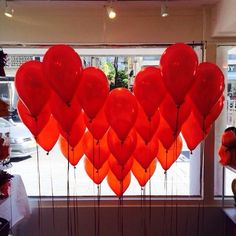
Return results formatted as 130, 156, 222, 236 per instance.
1, 46, 202, 196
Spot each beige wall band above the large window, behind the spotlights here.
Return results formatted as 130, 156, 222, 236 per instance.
0, 1, 204, 44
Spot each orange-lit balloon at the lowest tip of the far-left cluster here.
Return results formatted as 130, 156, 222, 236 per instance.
36, 116, 59, 152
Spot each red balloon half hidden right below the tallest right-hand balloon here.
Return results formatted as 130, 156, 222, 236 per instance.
160, 95, 191, 135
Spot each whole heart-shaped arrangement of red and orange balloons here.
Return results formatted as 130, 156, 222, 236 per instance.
15, 43, 224, 197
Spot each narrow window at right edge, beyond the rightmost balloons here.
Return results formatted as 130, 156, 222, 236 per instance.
215, 46, 236, 196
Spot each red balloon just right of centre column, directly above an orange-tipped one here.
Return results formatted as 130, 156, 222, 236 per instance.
133, 135, 159, 170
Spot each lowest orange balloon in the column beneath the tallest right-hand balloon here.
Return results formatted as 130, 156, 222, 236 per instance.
157, 136, 183, 171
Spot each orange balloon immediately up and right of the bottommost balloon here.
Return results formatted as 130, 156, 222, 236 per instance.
132, 159, 157, 187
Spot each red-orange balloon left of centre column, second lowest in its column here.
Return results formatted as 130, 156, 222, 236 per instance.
82, 131, 110, 170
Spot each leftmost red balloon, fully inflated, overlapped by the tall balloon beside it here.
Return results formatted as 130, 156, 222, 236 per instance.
15, 61, 50, 117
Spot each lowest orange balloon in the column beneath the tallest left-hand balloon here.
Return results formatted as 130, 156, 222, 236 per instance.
59, 136, 84, 166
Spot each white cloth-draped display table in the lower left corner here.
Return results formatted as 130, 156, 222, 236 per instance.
0, 175, 30, 227
